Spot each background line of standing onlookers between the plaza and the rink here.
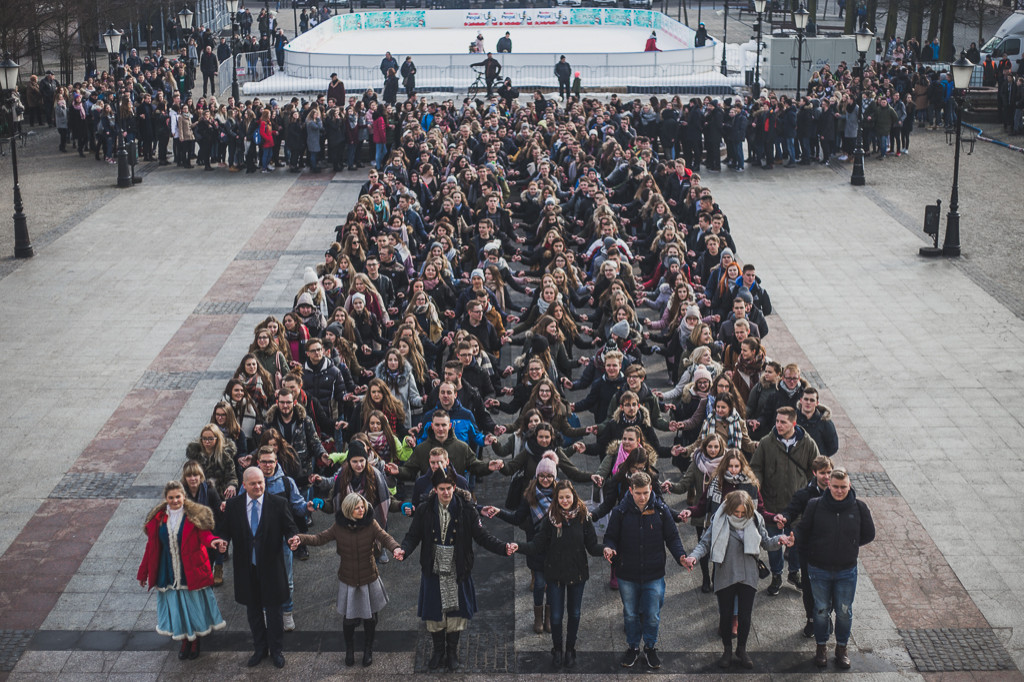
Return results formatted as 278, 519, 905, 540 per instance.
17, 36, 1024, 180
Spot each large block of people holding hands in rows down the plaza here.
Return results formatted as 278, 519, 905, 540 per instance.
132, 81, 873, 671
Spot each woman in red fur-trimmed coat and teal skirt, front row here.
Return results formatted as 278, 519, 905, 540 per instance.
137, 480, 227, 659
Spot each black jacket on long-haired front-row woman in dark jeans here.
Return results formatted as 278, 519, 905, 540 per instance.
519, 516, 604, 585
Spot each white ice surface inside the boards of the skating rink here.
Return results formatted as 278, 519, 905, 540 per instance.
302, 26, 683, 56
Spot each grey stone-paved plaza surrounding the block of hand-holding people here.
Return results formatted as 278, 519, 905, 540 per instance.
0, 119, 1024, 682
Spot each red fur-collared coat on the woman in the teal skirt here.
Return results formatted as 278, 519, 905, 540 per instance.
136, 500, 216, 590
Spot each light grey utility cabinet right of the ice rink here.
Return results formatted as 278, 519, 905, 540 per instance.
761, 33, 874, 91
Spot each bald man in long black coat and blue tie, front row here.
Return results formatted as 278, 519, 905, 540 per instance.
216, 467, 299, 668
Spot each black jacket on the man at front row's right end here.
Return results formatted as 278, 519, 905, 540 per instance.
796, 489, 874, 570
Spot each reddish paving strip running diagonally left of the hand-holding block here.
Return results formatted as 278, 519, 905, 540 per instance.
0, 175, 327, 647
